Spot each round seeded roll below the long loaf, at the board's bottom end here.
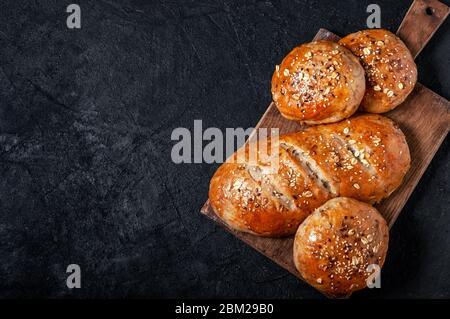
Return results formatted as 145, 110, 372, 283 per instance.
294, 197, 389, 297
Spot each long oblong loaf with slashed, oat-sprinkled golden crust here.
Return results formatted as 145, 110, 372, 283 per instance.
209, 114, 410, 236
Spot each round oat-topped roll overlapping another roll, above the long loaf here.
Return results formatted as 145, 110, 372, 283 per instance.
272, 41, 365, 124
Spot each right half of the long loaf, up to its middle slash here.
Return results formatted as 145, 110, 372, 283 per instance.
280, 114, 411, 203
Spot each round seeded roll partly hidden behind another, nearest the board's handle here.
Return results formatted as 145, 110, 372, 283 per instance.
339, 29, 417, 113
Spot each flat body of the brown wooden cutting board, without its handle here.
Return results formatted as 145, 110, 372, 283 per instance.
201, 1, 450, 296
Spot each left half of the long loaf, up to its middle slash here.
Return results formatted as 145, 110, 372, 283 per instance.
209, 141, 331, 237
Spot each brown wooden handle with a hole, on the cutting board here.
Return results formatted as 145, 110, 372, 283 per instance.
397, 0, 450, 58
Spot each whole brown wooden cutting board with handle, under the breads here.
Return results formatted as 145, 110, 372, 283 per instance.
201, 0, 450, 296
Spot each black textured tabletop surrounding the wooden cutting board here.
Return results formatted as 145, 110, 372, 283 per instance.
0, 0, 450, 298
